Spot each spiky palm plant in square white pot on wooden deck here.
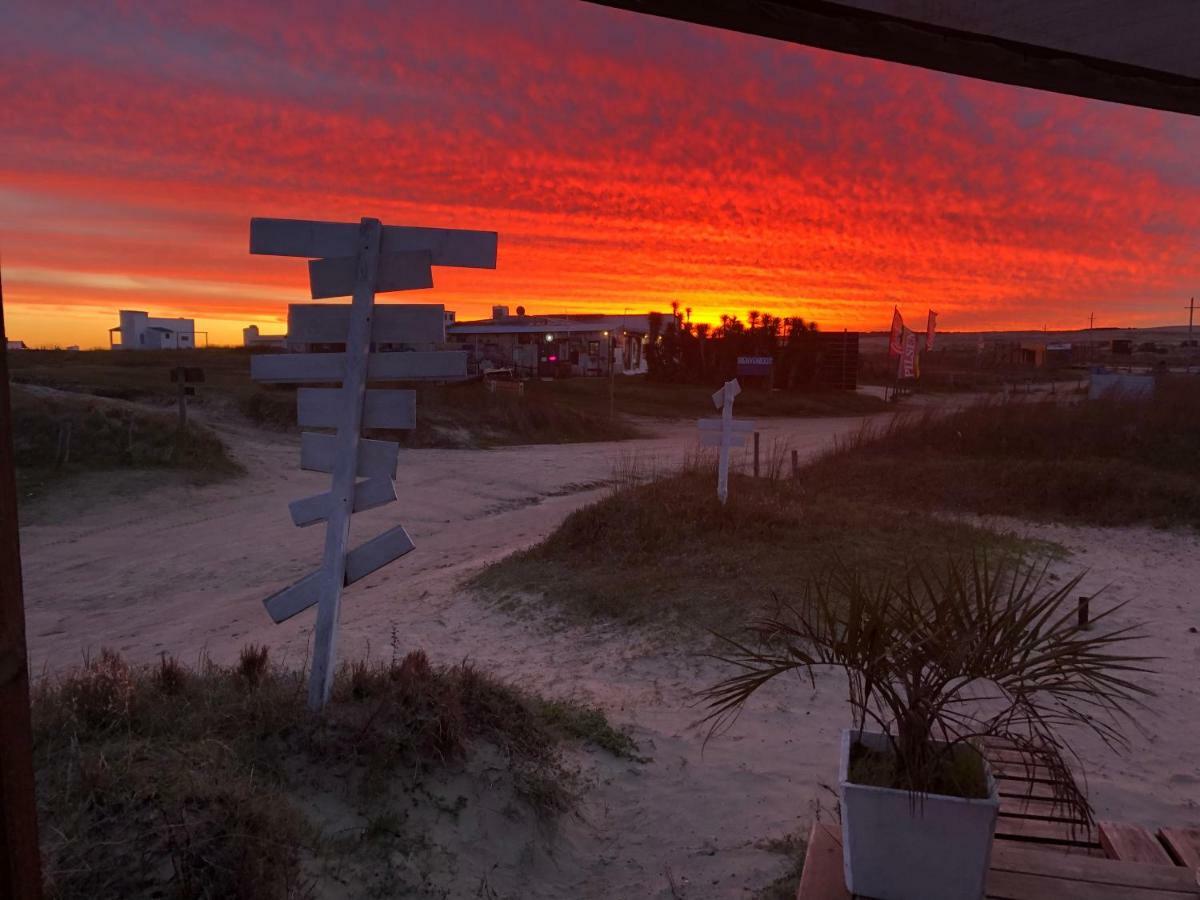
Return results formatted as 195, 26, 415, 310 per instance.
702, 556, 1148, 900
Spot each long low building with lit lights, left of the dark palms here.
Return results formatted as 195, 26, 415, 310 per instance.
446, 306, 668, 377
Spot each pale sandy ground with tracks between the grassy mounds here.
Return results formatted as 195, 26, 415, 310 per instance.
22, 405, 1200, 898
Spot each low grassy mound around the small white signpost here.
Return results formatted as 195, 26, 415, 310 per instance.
473, 452, 1051, 629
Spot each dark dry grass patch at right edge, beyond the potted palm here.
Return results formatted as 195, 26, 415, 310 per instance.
809, 377, 1200, 527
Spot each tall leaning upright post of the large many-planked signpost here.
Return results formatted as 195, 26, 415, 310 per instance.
308, 218, 383, 709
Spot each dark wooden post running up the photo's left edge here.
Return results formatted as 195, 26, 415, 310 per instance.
0, 264, 42, 900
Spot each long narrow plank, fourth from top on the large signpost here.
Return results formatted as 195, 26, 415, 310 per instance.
250, 350, 467, 384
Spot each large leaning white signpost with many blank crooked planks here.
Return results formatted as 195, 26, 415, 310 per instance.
250, 218, 497, 709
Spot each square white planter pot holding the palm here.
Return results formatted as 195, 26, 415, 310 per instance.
838, 730, 1000, 900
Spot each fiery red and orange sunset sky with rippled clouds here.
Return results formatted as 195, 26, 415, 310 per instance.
0, 0, 1200, 347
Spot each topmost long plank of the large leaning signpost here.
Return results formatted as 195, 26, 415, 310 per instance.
250, 218, 498, 269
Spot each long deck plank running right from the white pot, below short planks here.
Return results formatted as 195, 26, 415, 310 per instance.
991, 841, 1196, 900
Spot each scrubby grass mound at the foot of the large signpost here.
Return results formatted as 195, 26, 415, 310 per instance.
32, 647, 636, 900
